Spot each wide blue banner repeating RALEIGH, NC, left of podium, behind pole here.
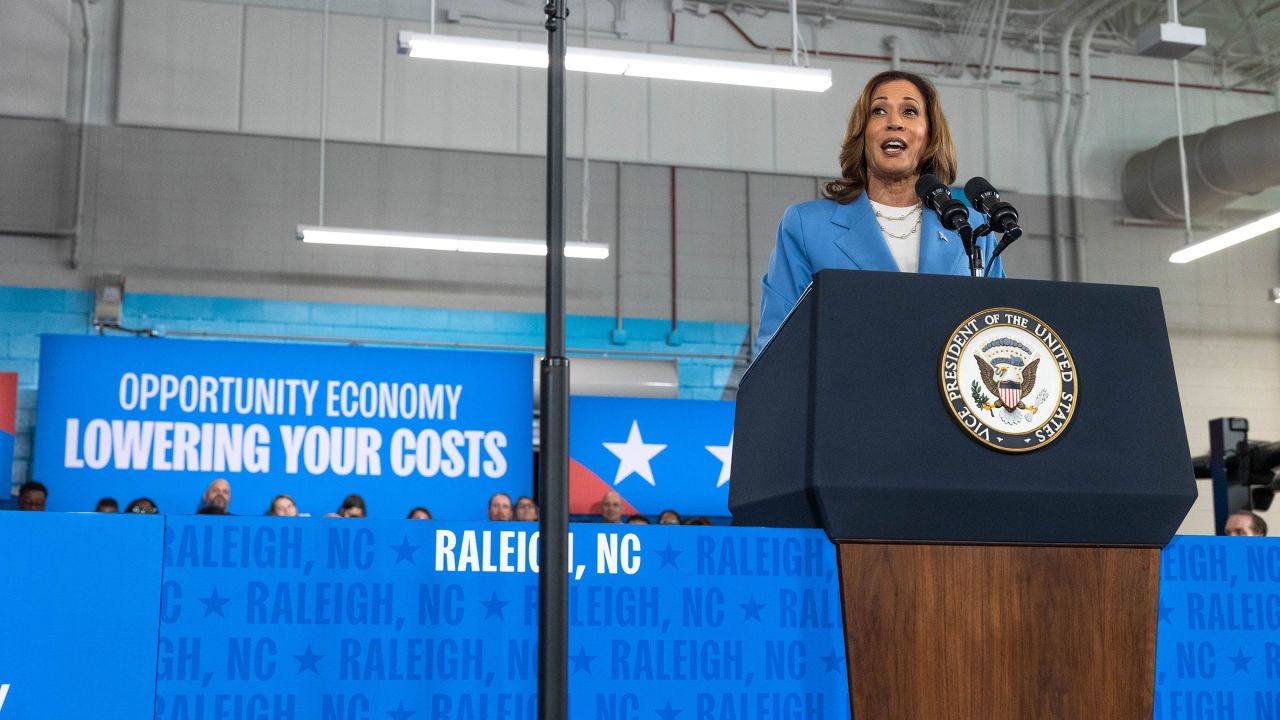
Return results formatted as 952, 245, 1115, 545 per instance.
156, 516, 849, 720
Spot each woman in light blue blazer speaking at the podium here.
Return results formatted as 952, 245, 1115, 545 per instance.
755, 70, 1005, 354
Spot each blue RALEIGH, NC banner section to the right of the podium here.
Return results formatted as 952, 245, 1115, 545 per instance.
1155, 537, 1280, 720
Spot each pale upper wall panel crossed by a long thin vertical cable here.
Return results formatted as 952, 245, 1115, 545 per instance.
242, 6, 383, 142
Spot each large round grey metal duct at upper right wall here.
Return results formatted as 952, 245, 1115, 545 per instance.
1123, 113, 1280, 220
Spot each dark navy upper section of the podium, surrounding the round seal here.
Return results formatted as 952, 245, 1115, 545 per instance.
730, 270, 1196, 546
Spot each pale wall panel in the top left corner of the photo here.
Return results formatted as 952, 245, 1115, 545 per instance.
0, 0, 71, 118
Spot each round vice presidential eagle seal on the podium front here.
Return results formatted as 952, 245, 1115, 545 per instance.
940, 307, 1079, 452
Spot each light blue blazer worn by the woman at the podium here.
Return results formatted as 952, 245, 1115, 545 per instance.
755, 192, 1005, 355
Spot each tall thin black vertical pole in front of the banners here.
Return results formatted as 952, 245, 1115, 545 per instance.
538, 0, 568, 720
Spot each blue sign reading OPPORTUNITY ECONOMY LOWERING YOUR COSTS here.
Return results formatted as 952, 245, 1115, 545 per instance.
33, 336, 532, 519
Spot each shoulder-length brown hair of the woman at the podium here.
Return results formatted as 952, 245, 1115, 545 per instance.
822, 70, 956, 205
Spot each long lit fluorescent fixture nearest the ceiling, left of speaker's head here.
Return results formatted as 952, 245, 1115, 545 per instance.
398, 29, 831, 92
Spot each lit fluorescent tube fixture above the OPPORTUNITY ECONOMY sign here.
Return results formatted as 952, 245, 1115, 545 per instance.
297, 225, 609, 260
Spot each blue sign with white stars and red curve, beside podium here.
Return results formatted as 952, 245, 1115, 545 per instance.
568, 397, 733, 516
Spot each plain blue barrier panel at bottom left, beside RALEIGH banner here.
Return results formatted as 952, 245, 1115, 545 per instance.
0, 512, 164, 720
